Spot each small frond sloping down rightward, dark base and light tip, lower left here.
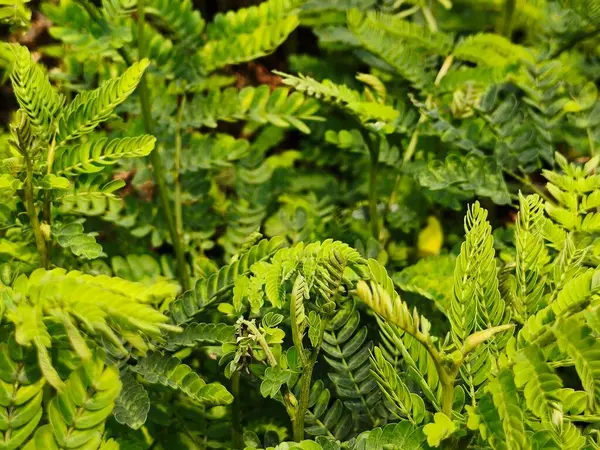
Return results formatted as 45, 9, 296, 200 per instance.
131, 352, 233, 406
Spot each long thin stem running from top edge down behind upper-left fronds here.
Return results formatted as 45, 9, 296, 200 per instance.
138, 0, 191, 291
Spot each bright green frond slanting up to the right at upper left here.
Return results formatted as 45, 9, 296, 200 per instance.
57, 59, 150, 145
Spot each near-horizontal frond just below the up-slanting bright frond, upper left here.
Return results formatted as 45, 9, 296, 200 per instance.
54, 134, 156, 176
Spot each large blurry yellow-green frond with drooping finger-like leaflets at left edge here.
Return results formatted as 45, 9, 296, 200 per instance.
7, 269, 177, 376
